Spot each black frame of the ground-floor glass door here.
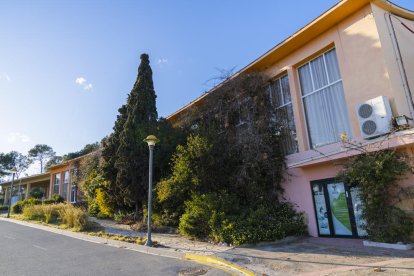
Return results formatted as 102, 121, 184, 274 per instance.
310, 178, 364, 239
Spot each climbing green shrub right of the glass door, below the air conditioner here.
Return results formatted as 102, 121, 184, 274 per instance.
338, 150, 414, 243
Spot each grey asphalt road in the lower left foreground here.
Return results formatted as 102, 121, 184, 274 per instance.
0, 221, 227, 276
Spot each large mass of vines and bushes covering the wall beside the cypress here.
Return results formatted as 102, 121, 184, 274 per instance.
156, 75, 306, 244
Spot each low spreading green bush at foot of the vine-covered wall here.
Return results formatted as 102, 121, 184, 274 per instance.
179, 194, 306, 245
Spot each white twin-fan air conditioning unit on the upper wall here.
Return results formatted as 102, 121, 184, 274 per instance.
356, 96, 392, 139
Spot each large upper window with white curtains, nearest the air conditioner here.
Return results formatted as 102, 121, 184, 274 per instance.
298, 49, 351, 148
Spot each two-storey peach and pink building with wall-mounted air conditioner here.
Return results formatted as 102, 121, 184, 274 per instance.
168, 0, 414, 237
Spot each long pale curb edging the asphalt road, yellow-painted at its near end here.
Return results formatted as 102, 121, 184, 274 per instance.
0, 217, 256, 276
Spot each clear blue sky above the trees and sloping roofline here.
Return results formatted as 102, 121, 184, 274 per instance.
0, 0, 414, 155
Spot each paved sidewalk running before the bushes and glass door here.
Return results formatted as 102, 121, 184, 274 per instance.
94, 219, 414, 276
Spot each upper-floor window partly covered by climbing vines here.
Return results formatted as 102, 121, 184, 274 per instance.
270, 75, 298, 154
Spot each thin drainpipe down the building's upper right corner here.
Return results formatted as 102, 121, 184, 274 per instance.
384, 12, 414, 119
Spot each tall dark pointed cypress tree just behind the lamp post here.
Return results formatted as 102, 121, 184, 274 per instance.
114, 54, 158, 217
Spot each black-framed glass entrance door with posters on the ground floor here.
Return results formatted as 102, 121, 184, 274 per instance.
311, 179, 366, 237
